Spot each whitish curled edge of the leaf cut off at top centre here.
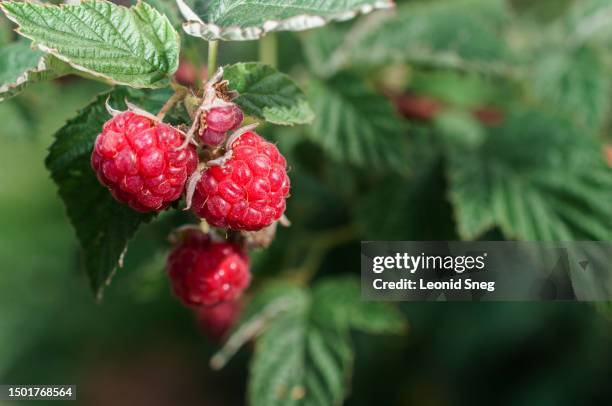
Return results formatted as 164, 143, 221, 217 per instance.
176, 0, 395, 41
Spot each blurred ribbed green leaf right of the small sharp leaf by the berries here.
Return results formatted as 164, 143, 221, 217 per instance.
309, 73, 407, 171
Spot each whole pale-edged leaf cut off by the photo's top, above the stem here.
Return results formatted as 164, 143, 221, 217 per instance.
177, 0, 393, 41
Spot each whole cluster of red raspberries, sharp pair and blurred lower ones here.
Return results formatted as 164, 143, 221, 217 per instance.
91, 103, 289, 337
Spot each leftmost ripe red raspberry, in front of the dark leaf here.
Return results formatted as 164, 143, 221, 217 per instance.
91, 112, 198, 212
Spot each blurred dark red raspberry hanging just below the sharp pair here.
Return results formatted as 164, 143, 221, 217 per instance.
167, 232, 251, 306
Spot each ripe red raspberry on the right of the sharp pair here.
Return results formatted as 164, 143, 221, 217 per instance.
192, 132, 289, 231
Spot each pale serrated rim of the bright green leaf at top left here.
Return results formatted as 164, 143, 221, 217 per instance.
0, 0, 180, 89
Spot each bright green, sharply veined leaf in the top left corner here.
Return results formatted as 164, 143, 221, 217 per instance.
1, 0, 179, 88
